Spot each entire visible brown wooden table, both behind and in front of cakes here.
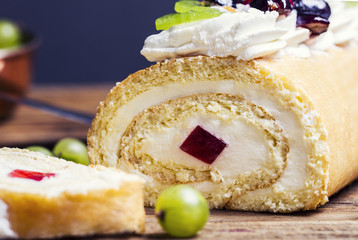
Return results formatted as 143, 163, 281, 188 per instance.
0, 84, 358, 239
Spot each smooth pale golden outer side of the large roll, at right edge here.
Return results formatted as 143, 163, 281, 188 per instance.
261, 48, 358, 196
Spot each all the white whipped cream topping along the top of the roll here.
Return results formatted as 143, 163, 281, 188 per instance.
141, 1, 358, 62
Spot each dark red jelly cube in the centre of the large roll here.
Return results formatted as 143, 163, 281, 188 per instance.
180, 126, 227, 164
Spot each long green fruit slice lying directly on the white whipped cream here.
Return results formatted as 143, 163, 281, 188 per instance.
155, 8, 222, 31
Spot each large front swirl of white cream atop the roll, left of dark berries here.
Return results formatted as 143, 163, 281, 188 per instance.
141, 8, 309, 61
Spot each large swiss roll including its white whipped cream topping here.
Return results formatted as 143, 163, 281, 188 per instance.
88, 1, 358, 212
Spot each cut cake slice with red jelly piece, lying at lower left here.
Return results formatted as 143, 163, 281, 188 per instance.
0, 148, 145, 239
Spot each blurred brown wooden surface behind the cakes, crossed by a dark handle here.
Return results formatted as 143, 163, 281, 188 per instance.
0, 85, 112, 147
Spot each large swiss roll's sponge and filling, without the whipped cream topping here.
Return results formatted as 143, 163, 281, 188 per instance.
88, 47, 358, 212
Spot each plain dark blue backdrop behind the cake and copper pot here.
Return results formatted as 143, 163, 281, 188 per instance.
0, 0, 175, 84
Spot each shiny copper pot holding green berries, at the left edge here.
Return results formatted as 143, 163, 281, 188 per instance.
0, 31, 40, 120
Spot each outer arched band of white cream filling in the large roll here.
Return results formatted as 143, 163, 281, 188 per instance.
112, 80, 308, 191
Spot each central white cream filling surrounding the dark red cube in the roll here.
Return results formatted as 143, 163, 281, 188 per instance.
140, 113, 268, 179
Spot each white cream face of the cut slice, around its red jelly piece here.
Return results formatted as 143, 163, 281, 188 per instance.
0, 152, 143, 197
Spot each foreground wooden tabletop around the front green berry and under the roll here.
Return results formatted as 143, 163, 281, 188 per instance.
140, 181, 358, 239
